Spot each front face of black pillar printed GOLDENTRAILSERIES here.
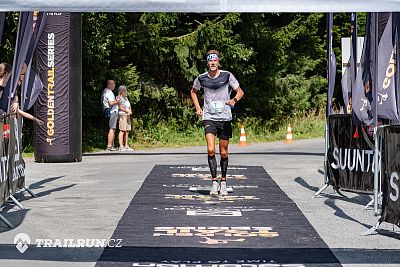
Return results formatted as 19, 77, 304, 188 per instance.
36, 13, 69, 155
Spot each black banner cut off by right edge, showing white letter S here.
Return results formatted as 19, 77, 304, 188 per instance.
380, 125, 400, 227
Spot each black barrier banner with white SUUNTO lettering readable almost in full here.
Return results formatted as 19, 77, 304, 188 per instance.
328, 114, 374, 191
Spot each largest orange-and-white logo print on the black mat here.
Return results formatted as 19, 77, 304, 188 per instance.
153, 226, 279, 245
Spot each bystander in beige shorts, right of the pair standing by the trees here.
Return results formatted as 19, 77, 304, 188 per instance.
118, 85, 132, 151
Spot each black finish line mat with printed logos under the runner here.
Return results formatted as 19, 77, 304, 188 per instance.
96, 165, 341, 267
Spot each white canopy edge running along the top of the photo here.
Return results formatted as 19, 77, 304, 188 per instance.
0, 0, 400, 13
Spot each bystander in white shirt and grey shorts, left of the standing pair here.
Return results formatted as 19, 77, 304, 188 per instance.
101, 79, 120, 151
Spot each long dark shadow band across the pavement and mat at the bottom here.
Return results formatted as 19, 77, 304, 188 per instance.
0, 244, 400, 266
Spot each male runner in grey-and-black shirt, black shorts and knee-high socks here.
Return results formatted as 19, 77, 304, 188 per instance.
190, 50, 244, 196
